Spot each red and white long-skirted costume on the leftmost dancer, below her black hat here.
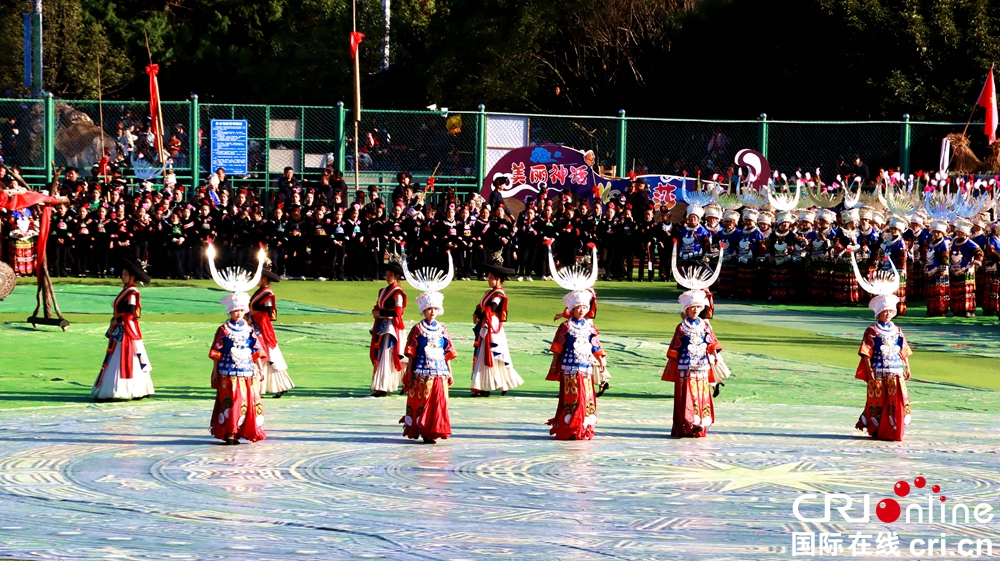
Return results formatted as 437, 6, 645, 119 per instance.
90, 284, 154, 400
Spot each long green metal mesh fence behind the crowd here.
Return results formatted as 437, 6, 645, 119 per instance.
0, 95, 986, 199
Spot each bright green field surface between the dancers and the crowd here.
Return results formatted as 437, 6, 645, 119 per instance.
0, 279, 1000, 411
